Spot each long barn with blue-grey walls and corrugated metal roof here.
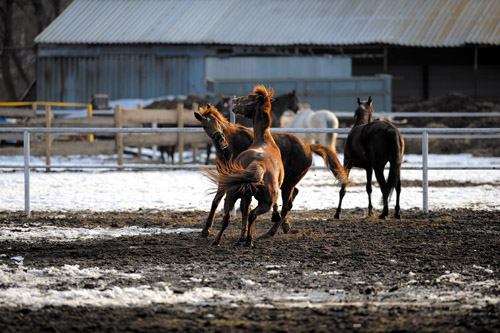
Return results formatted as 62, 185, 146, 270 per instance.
35, 0, 500, 107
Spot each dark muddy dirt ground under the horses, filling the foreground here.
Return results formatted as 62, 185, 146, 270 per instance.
0, 209, 500, 332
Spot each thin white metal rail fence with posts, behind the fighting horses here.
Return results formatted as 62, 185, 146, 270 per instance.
0, 127, 500, 215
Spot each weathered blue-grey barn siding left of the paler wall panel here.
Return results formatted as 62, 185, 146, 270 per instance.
37, 54, 205, 103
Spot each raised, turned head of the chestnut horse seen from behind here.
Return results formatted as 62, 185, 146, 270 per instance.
233, 85, 274, 119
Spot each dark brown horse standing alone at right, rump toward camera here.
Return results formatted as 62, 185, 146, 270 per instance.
335, 96, 404, 219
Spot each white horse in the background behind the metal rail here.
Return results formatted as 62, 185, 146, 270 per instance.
285, 108, 339, 152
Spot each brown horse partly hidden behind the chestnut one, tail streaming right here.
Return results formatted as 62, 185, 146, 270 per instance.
195, 105, 347, 237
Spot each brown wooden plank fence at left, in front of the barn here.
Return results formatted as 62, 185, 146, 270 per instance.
0, 104, 210, 165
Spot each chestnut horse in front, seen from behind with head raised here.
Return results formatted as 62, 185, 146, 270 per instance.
204, 86, 285, 246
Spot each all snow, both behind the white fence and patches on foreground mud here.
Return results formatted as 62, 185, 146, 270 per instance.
0, 155, 500, 309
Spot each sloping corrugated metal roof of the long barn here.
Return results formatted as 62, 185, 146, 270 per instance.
35, 0, 500, 47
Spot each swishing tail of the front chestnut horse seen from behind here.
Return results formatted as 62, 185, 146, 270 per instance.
203, 160, 264, 193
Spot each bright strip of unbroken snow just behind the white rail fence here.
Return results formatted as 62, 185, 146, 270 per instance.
0, 154, 500, 211
